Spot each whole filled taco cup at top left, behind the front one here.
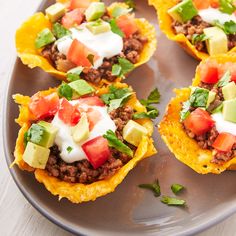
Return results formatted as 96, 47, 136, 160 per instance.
15, 0, 156, 85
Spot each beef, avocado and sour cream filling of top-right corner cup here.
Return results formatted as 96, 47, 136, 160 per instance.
168, 0, 236, 55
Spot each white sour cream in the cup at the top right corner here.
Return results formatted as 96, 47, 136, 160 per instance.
198, 7, 236, 24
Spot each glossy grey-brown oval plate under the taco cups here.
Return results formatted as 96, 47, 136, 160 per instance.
3, 0, 236, 235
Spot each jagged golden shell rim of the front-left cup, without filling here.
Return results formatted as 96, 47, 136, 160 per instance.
13, 83, 156, 203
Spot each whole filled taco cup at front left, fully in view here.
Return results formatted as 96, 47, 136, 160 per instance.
12, 80, 156, 203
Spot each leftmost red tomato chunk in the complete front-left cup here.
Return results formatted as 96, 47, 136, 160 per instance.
29, 92, 59, 119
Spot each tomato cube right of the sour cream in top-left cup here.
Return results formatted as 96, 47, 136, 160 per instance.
116, 15, 138, 38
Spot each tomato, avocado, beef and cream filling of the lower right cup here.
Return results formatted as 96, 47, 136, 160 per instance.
180, 60, 236, 165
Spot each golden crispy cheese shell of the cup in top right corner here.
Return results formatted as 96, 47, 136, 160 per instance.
149, 0, 236, 60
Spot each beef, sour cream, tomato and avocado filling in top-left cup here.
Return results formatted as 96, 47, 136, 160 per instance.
35, 0, 148, 83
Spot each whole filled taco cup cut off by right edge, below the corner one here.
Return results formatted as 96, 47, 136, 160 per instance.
159, 54, 236, 174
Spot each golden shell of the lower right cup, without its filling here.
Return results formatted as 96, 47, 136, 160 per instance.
159, 54, 236, 174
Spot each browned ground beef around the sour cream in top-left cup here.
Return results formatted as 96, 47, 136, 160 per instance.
41, 32, 148, 84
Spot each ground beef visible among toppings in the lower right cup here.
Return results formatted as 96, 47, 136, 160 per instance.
183, 82, 236, 165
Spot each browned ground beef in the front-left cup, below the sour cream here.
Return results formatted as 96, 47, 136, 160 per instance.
46, 106, 136, 184
